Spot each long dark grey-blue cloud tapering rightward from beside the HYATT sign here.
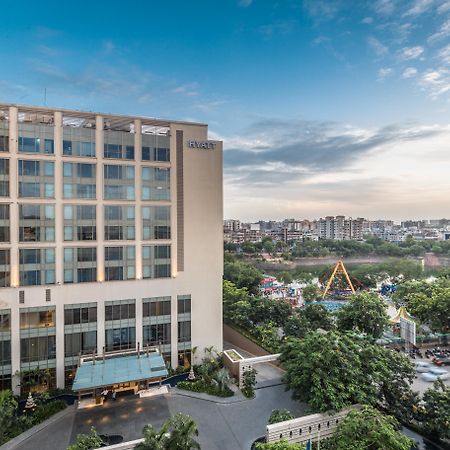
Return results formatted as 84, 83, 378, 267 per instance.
224, 120, 439, 185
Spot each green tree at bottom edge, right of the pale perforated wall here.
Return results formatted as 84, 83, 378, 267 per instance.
320, 407, 413, 450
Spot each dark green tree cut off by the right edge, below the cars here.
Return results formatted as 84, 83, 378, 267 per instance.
421, 380, 450, 439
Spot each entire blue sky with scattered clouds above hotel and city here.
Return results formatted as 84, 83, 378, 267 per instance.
0, 0, 450, 220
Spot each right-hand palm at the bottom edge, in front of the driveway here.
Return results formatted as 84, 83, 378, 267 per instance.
163, 413, 200, 450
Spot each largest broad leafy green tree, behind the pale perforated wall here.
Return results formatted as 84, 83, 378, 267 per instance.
280, 332, 415, 412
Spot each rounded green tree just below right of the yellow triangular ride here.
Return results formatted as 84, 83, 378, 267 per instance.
337, 292, 389, 338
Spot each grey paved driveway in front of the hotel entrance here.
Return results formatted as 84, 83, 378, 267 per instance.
16, 385, 305, 450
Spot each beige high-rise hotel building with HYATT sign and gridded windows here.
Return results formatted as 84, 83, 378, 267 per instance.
0, 104, 223, 392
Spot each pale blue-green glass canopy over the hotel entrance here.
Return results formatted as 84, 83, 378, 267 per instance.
72, 352, 168, 391
